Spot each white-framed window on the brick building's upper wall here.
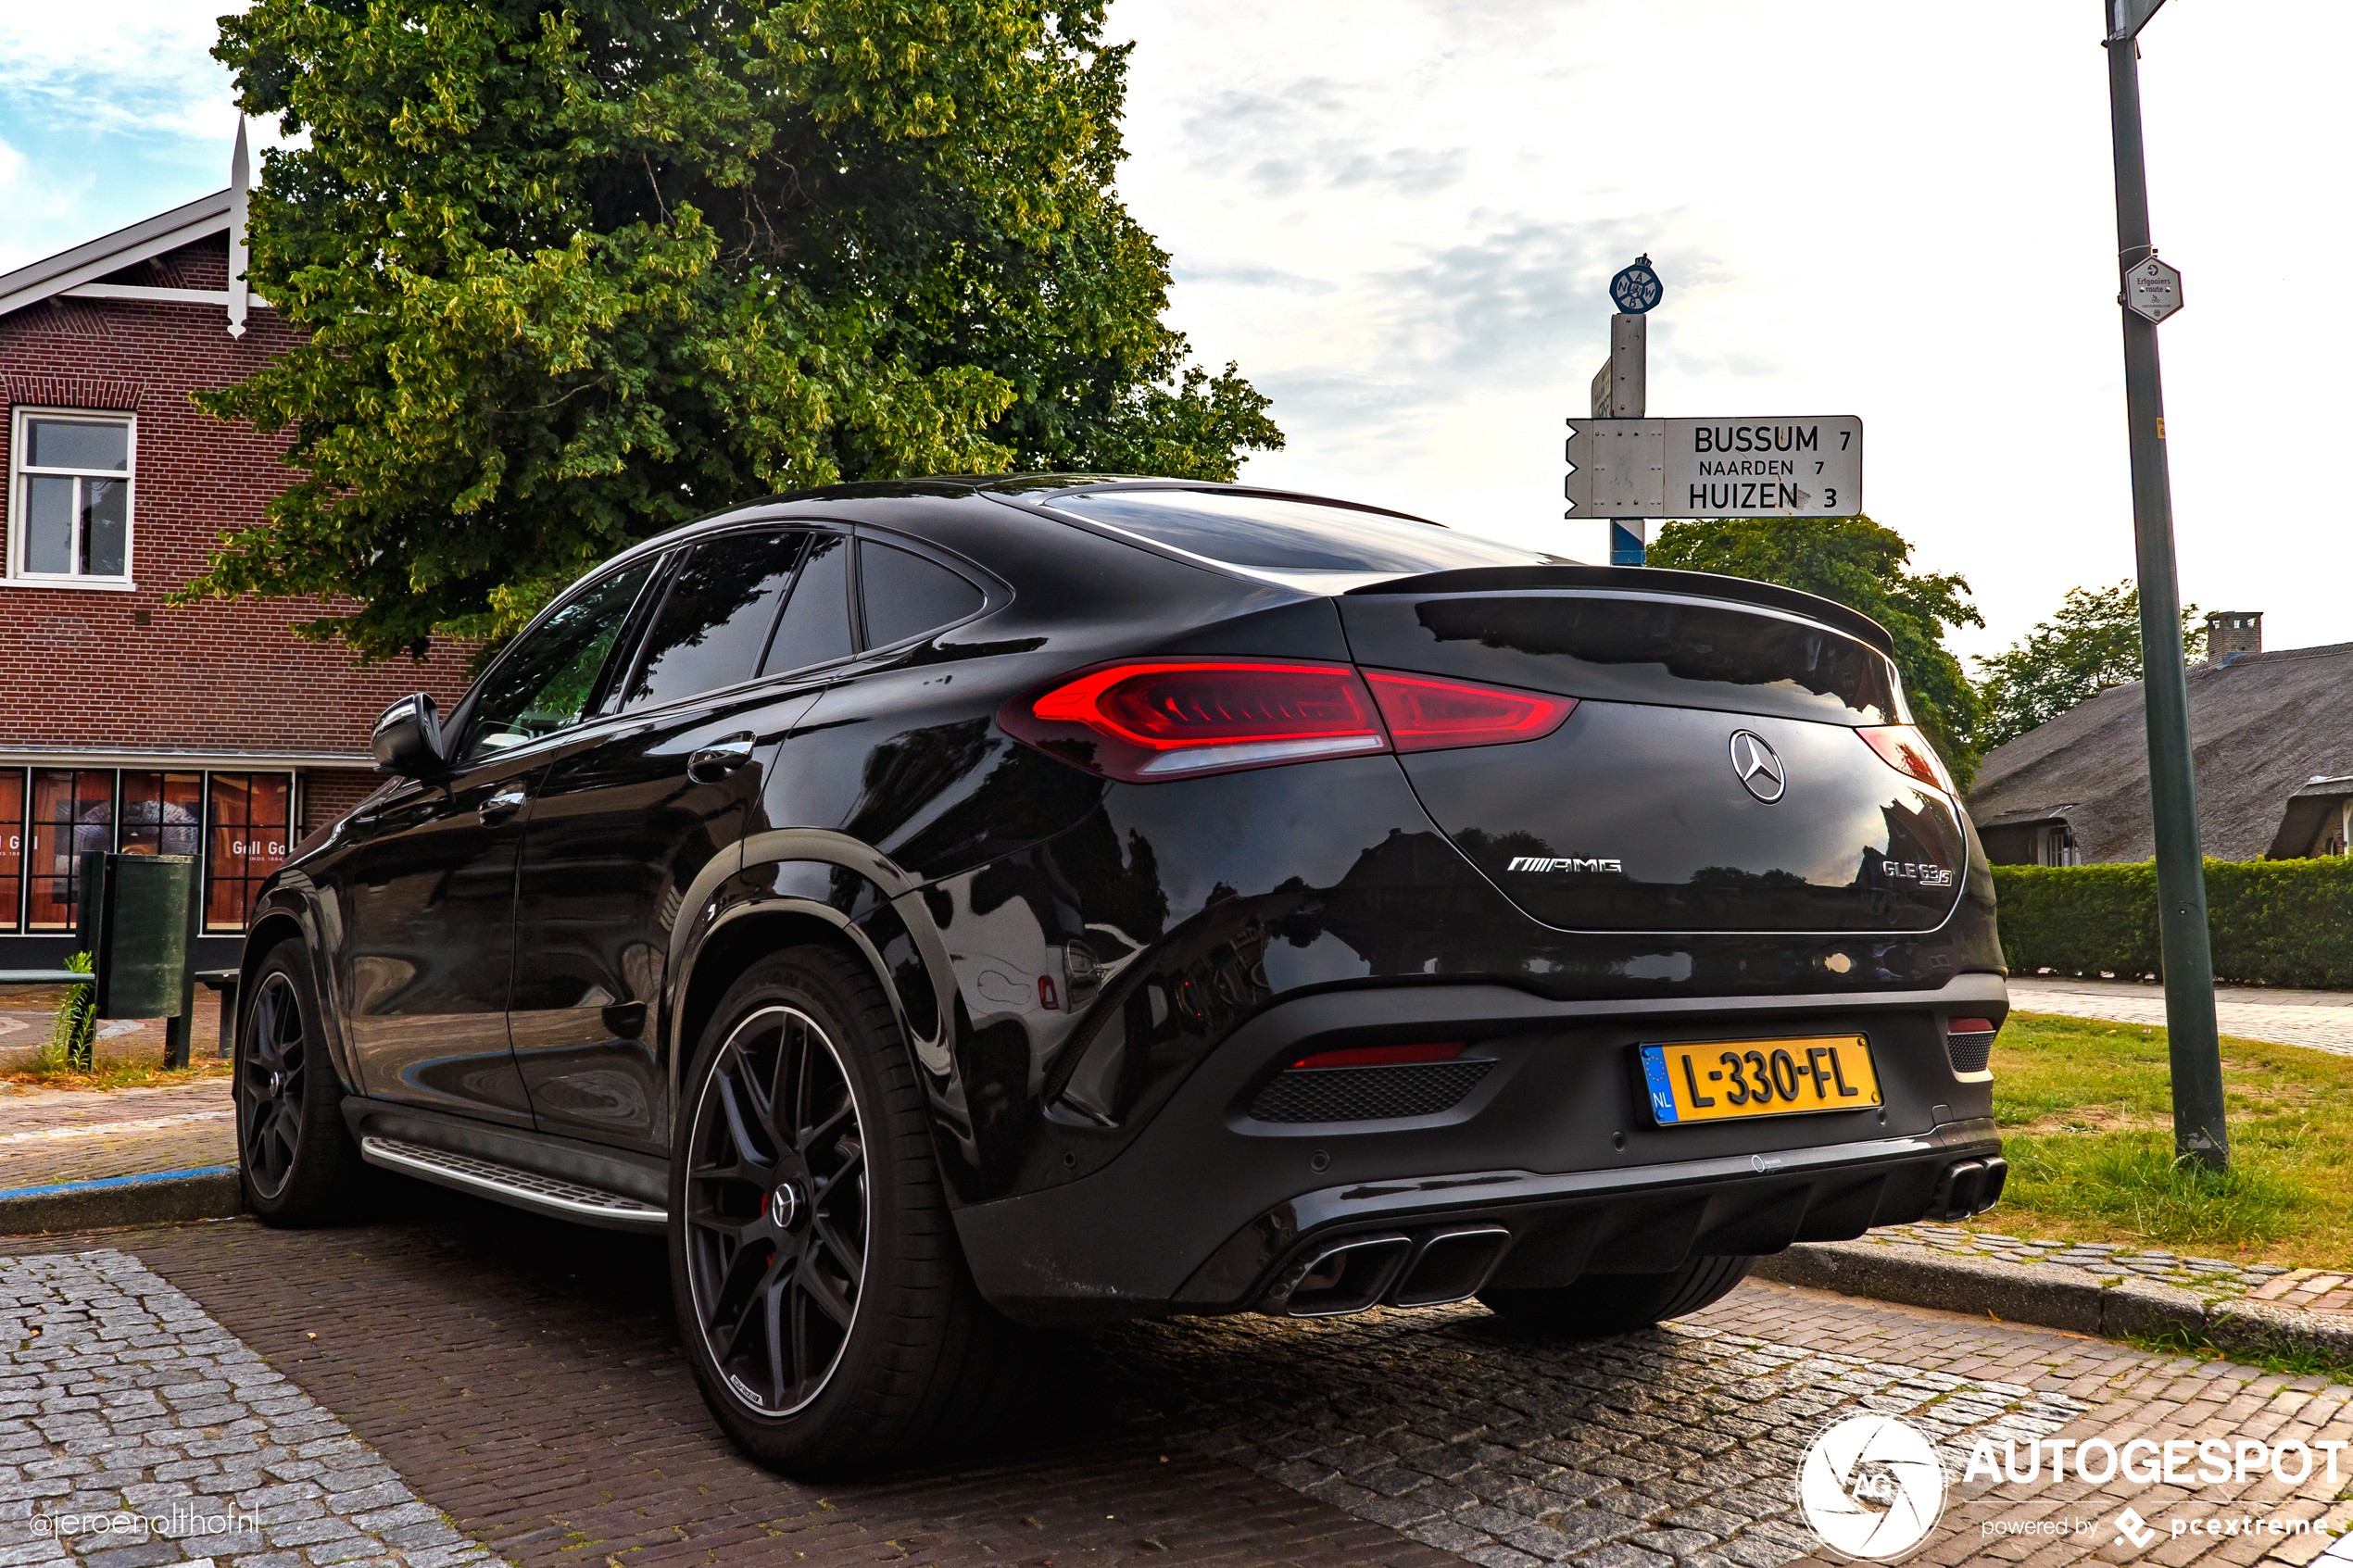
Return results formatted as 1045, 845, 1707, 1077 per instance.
9, 409, 136, 585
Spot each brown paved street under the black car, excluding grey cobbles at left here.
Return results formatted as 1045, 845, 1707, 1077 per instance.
0, 1185, 2353, 1568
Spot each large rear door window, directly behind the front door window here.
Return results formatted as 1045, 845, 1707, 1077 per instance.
619, 532, 807, 710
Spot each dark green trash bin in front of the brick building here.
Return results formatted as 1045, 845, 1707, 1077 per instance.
75, 851, 197, 1067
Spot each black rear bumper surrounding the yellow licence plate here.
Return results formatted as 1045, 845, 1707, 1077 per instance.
958, 975, 2007, 1321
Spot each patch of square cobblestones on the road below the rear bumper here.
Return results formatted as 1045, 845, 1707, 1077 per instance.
1118, 1307, 2084, 1568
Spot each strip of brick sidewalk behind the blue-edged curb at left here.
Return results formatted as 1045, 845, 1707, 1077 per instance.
0, 1079, 238, 1194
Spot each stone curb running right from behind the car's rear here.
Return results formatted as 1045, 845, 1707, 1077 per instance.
1751, 1241, 2353, 1363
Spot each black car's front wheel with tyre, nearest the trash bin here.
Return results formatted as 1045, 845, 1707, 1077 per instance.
233, 940, 367, 1224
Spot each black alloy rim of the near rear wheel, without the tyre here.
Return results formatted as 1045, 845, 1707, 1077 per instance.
685, 1006, 871, 1418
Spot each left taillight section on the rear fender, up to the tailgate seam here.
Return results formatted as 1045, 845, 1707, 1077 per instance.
998, 660, 1389, 783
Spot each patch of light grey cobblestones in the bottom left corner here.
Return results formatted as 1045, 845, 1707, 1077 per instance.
0, 1248, 492, 1568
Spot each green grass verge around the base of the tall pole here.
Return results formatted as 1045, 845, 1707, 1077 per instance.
1979, 1013, 2353, 1267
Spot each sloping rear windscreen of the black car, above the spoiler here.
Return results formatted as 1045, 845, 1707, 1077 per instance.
1050, 489, 1555, 571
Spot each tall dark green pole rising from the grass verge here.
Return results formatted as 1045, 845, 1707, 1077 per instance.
2101, 0, 2231, 1171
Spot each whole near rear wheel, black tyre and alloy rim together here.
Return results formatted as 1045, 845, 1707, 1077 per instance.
671, 945, 1036, 1479
